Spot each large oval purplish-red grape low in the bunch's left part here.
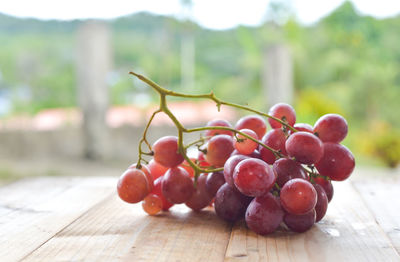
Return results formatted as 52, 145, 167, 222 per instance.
161, 167, 194, 204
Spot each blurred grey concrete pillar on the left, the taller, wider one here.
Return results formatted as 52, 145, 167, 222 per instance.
77, 21, 112, 159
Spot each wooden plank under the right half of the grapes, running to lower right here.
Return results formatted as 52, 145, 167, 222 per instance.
225, 182, 400, 261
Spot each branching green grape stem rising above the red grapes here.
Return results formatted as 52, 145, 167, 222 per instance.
129, 72, 297, 180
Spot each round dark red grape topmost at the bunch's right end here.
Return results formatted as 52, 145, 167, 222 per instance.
314, 114, 348, 143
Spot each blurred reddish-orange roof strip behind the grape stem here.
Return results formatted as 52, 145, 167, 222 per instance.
0, 101, 237, 130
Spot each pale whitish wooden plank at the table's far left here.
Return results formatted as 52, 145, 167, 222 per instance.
0, 177, 116, 261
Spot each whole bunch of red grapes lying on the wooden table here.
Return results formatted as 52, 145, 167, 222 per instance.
117, 103, 355, 235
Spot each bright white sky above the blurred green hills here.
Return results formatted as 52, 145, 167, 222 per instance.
0, 0, 400, 29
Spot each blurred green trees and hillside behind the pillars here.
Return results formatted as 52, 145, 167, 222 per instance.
0, 2, 400, 165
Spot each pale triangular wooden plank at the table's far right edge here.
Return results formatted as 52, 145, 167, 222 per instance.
353, 178, 400, 254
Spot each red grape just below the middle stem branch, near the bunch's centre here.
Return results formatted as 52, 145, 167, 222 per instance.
205, 135, 233, 167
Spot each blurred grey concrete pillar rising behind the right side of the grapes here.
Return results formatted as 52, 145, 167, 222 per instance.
262, 44, 293, 109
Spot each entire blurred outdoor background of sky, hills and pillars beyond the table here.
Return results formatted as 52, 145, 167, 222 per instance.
0, 0, 400, 181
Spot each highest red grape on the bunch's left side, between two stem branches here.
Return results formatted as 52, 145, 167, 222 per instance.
153, 136, 184, 167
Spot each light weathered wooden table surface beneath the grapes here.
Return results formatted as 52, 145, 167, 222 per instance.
0, 177, 400, 262
